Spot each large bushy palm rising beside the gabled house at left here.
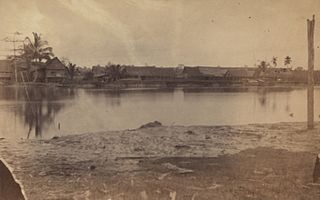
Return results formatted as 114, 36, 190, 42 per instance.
23, 32, 54, 81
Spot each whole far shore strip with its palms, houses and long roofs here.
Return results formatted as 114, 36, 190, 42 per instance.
0, 33, 320, 88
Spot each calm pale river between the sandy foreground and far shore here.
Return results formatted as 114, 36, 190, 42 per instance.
0, 87, 320, 138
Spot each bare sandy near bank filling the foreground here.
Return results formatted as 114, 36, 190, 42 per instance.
0, 123, 320, 200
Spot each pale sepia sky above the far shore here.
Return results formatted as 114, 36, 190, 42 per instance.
0, 0, 320, 69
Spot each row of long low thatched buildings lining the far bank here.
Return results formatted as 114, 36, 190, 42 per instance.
92, 65, 320, 83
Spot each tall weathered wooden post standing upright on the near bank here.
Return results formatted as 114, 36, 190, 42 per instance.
307, 15, 315, 129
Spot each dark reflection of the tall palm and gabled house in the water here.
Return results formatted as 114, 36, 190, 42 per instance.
0, 87, 75, 138
